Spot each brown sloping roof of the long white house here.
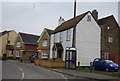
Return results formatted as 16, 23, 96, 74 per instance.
53, 11, 90, 33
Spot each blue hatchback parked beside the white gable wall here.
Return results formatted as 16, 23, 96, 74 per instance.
92, 58, 119, 72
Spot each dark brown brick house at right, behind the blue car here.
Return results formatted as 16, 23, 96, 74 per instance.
98, 15, 120, 65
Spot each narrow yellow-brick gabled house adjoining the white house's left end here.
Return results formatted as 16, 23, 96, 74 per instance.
37, 28, 53, 59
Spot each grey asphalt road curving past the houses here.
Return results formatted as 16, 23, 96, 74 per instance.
2, 61, 95, 81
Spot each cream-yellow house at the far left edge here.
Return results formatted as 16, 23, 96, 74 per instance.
0, 30, 17, 58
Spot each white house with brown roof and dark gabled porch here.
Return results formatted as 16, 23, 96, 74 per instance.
50, 11, 101, 66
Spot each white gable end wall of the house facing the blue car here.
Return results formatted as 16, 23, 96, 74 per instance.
76, 13, 101, 66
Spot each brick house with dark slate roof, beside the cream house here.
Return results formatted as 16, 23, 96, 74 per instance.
14, 32, 39, 61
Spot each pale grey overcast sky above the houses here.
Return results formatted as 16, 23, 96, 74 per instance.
0, 0, 118, 35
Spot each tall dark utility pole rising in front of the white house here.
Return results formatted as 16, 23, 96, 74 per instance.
72, 0, 76, 47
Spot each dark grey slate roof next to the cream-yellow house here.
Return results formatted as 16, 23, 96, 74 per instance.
19, 32, 39, 45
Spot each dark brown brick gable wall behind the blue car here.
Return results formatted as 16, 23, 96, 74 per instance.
101, 17, 120, 59
